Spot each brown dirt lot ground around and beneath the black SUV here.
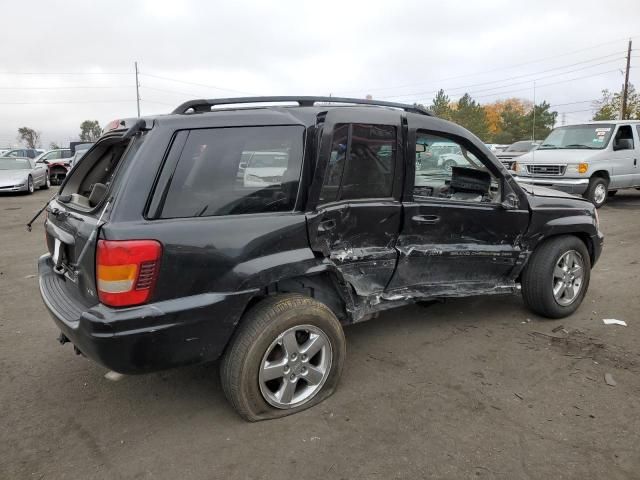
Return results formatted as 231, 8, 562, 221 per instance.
0, 191, 640, 480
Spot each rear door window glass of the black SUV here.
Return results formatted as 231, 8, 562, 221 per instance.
320, 123, 396, 203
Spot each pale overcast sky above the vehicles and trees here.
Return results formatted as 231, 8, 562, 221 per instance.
0, 0, 640, 147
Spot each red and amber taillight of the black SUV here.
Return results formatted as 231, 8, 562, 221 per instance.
96, 240, 162, 307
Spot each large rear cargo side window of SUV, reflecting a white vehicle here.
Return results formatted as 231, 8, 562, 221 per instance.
160, 126, 304, 218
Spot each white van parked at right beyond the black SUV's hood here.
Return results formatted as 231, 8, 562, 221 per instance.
515, 120, 640, 207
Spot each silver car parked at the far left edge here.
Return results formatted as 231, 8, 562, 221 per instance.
0, 157, 51, 194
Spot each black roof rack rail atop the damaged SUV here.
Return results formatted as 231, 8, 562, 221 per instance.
171, 96, 433, 115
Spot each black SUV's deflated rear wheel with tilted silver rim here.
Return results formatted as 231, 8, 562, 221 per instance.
220, 294, 346, 422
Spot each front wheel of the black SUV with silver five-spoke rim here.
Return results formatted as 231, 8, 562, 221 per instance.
522, 235, 591, 318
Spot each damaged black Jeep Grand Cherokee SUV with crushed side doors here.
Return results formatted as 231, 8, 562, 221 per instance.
38, 97, 603, 420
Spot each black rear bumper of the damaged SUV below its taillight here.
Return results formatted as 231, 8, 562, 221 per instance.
38, 254, 255, 373
